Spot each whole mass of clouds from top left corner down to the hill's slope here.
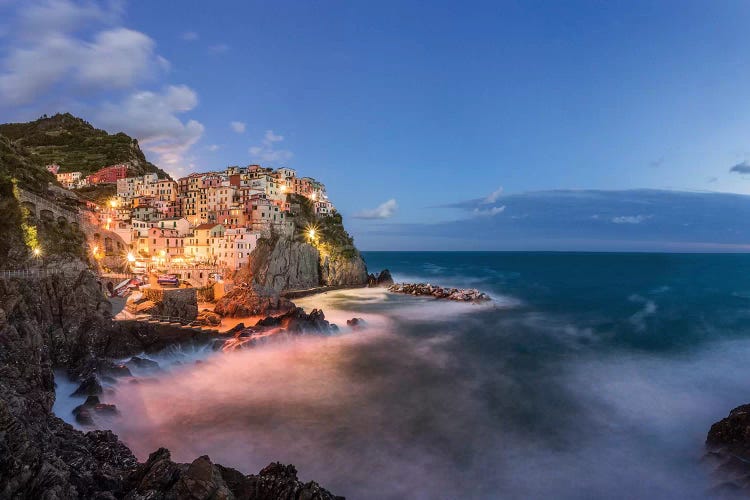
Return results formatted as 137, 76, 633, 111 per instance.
0, 0, 204, 173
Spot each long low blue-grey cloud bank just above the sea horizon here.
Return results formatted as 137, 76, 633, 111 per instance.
355, 189, 750, 251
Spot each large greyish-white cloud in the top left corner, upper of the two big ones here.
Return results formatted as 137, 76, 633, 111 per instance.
0, 0, 168, 106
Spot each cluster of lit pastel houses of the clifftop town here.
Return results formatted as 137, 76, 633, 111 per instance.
47, 164, 335, 284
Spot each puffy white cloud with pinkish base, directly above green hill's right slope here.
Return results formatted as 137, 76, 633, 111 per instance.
97, 85, 209, 172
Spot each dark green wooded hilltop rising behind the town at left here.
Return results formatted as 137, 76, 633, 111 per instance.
0, 113, 168, 177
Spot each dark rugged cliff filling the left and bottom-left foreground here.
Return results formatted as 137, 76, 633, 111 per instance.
0, 271, 346, 499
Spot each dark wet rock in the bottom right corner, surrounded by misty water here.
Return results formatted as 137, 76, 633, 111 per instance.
705, 404, 750, 495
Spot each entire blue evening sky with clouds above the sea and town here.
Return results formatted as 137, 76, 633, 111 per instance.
0, 0, 750, 251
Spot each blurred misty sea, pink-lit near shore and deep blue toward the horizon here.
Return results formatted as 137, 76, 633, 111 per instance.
55, 252, 750, 499
